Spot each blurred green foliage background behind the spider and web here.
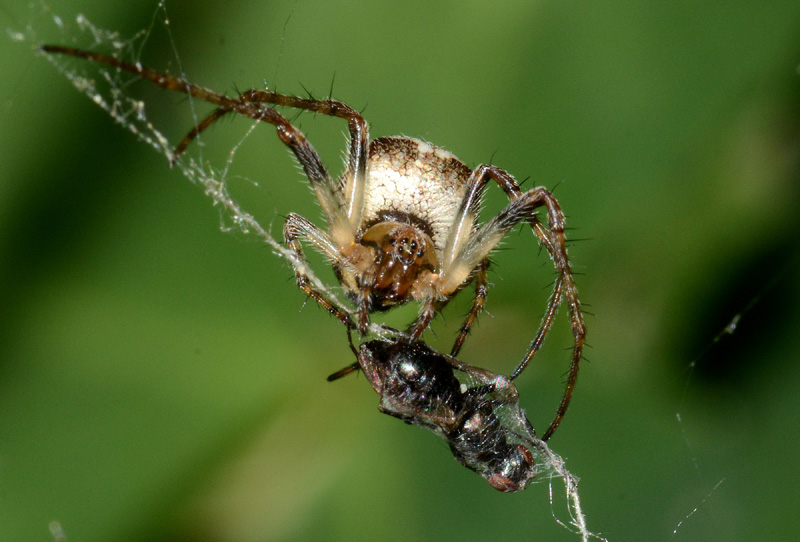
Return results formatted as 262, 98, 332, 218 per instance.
0, 0, 800, 541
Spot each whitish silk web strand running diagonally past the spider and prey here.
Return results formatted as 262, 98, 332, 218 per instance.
14, 0, 606, 541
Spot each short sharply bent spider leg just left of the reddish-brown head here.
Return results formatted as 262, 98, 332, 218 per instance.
283, 213, 354, 329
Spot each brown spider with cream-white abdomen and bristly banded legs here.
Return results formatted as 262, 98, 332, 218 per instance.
40, 45, 586, 439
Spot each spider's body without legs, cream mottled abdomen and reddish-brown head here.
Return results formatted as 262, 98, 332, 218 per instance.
324, 137, 482, 329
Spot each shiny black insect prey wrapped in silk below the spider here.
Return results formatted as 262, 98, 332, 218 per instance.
354, 338, 541, 493
